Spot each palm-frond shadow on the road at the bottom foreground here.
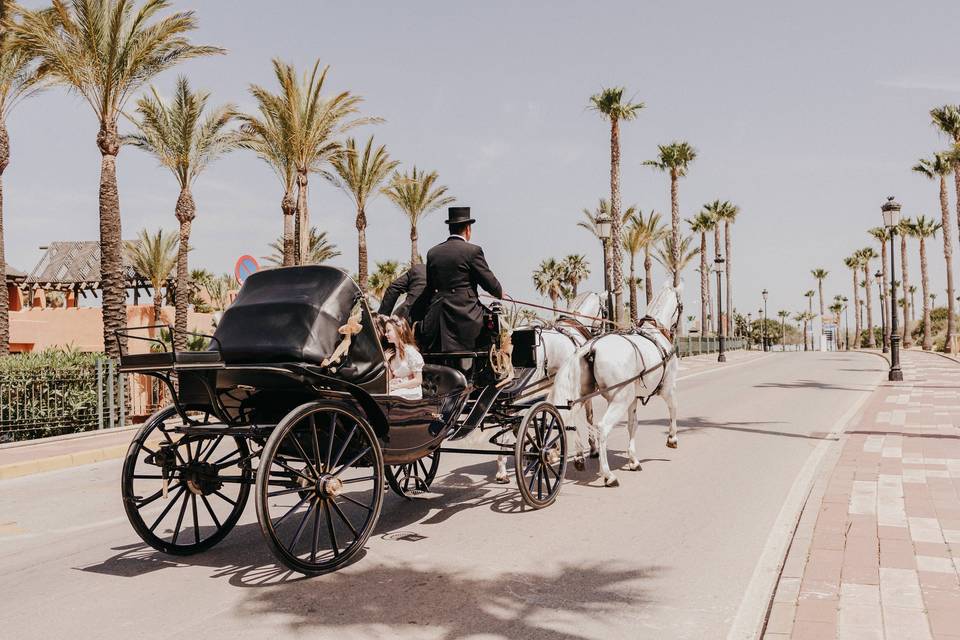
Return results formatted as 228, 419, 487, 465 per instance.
240, 563, 661, 640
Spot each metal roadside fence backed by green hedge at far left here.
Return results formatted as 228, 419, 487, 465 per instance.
0, 358, 164, 444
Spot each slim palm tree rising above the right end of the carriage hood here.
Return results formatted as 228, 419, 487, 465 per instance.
331, 136, 400, 290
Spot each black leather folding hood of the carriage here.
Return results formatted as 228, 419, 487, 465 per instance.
214, 265, 383, 381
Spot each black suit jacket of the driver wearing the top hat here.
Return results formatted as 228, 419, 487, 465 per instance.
421, 236, 503, 351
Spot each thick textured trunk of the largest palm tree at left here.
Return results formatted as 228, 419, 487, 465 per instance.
97, 123, 127, 359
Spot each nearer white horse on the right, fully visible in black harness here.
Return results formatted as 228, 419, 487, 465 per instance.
549, 285, 683, 487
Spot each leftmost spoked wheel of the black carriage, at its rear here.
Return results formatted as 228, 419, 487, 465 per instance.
122, 405, 253, 555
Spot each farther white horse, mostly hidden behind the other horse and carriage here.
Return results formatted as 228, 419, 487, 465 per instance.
496, 292, 603, 484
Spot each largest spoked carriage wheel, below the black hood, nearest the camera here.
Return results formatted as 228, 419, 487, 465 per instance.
257, 402, 384, 574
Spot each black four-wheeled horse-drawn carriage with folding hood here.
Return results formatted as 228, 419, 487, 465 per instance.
121, 266, 567, 574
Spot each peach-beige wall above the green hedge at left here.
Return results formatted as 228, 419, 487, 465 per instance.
10, 304, 213, 353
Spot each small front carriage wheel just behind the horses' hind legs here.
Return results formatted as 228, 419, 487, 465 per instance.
514, 402, 567, 509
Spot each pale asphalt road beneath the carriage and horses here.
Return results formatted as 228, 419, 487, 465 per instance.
0, 353, 884, 640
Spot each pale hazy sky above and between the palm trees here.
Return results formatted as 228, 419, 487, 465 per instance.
4, 0, 960, 314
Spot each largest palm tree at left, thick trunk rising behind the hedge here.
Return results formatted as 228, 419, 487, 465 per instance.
7, 0, 224, 358
